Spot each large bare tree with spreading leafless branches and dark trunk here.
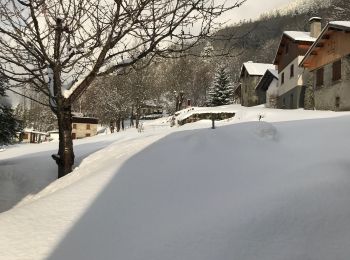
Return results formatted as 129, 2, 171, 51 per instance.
0, 0, 246, 177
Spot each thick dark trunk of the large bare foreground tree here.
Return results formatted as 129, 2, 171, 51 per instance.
53, 106, 74, 178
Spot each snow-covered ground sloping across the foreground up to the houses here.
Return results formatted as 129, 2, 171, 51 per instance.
0, 105, 350, 260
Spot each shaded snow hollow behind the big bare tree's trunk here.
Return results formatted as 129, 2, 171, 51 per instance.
0, 141, 110, 213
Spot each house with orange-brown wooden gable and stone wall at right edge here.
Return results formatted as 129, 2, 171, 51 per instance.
300, 21, 350, 110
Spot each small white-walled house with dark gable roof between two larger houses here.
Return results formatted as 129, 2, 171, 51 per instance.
255, 69, 278, 108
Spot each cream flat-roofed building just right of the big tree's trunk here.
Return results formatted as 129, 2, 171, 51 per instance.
72, 115, 98, 139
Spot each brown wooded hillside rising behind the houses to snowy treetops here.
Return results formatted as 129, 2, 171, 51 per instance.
13, 0, 350, 130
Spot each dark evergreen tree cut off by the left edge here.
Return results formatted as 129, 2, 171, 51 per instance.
0, 78, 21, 146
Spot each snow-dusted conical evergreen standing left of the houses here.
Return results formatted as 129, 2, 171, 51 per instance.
207, 66, 233, 107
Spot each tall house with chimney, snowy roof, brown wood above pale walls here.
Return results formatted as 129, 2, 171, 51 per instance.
273, 17, 321, 109
